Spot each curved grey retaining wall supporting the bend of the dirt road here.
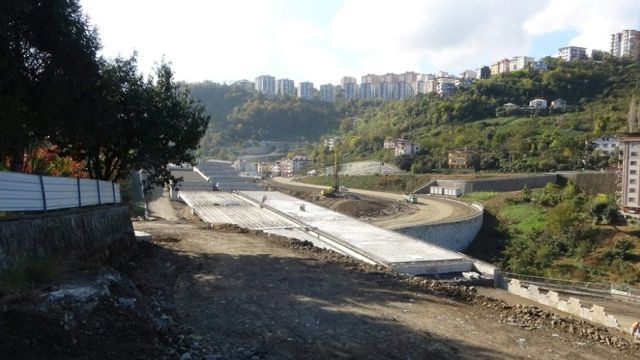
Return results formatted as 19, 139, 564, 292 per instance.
396, 204, 484, 251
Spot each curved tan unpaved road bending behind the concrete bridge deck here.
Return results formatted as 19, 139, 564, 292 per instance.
271, 177, 478, 230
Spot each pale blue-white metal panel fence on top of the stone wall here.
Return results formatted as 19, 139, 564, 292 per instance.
0, 172, 121, 211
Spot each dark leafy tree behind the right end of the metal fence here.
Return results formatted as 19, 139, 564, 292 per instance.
63, 55, 209, 185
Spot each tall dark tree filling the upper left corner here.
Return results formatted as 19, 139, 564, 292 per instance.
0, 0, 99, 171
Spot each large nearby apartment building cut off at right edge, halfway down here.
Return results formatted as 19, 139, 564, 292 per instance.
619, 133, 640, 217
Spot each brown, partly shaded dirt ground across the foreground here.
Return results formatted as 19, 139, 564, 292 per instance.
135, 215, 637, 359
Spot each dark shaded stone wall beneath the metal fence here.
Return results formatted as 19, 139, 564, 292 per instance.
0, 206, 135, 270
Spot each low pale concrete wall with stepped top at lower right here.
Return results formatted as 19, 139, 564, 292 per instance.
507, 279, 624, 331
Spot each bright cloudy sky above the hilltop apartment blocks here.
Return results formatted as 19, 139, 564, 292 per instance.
80, 0, 640, 87
